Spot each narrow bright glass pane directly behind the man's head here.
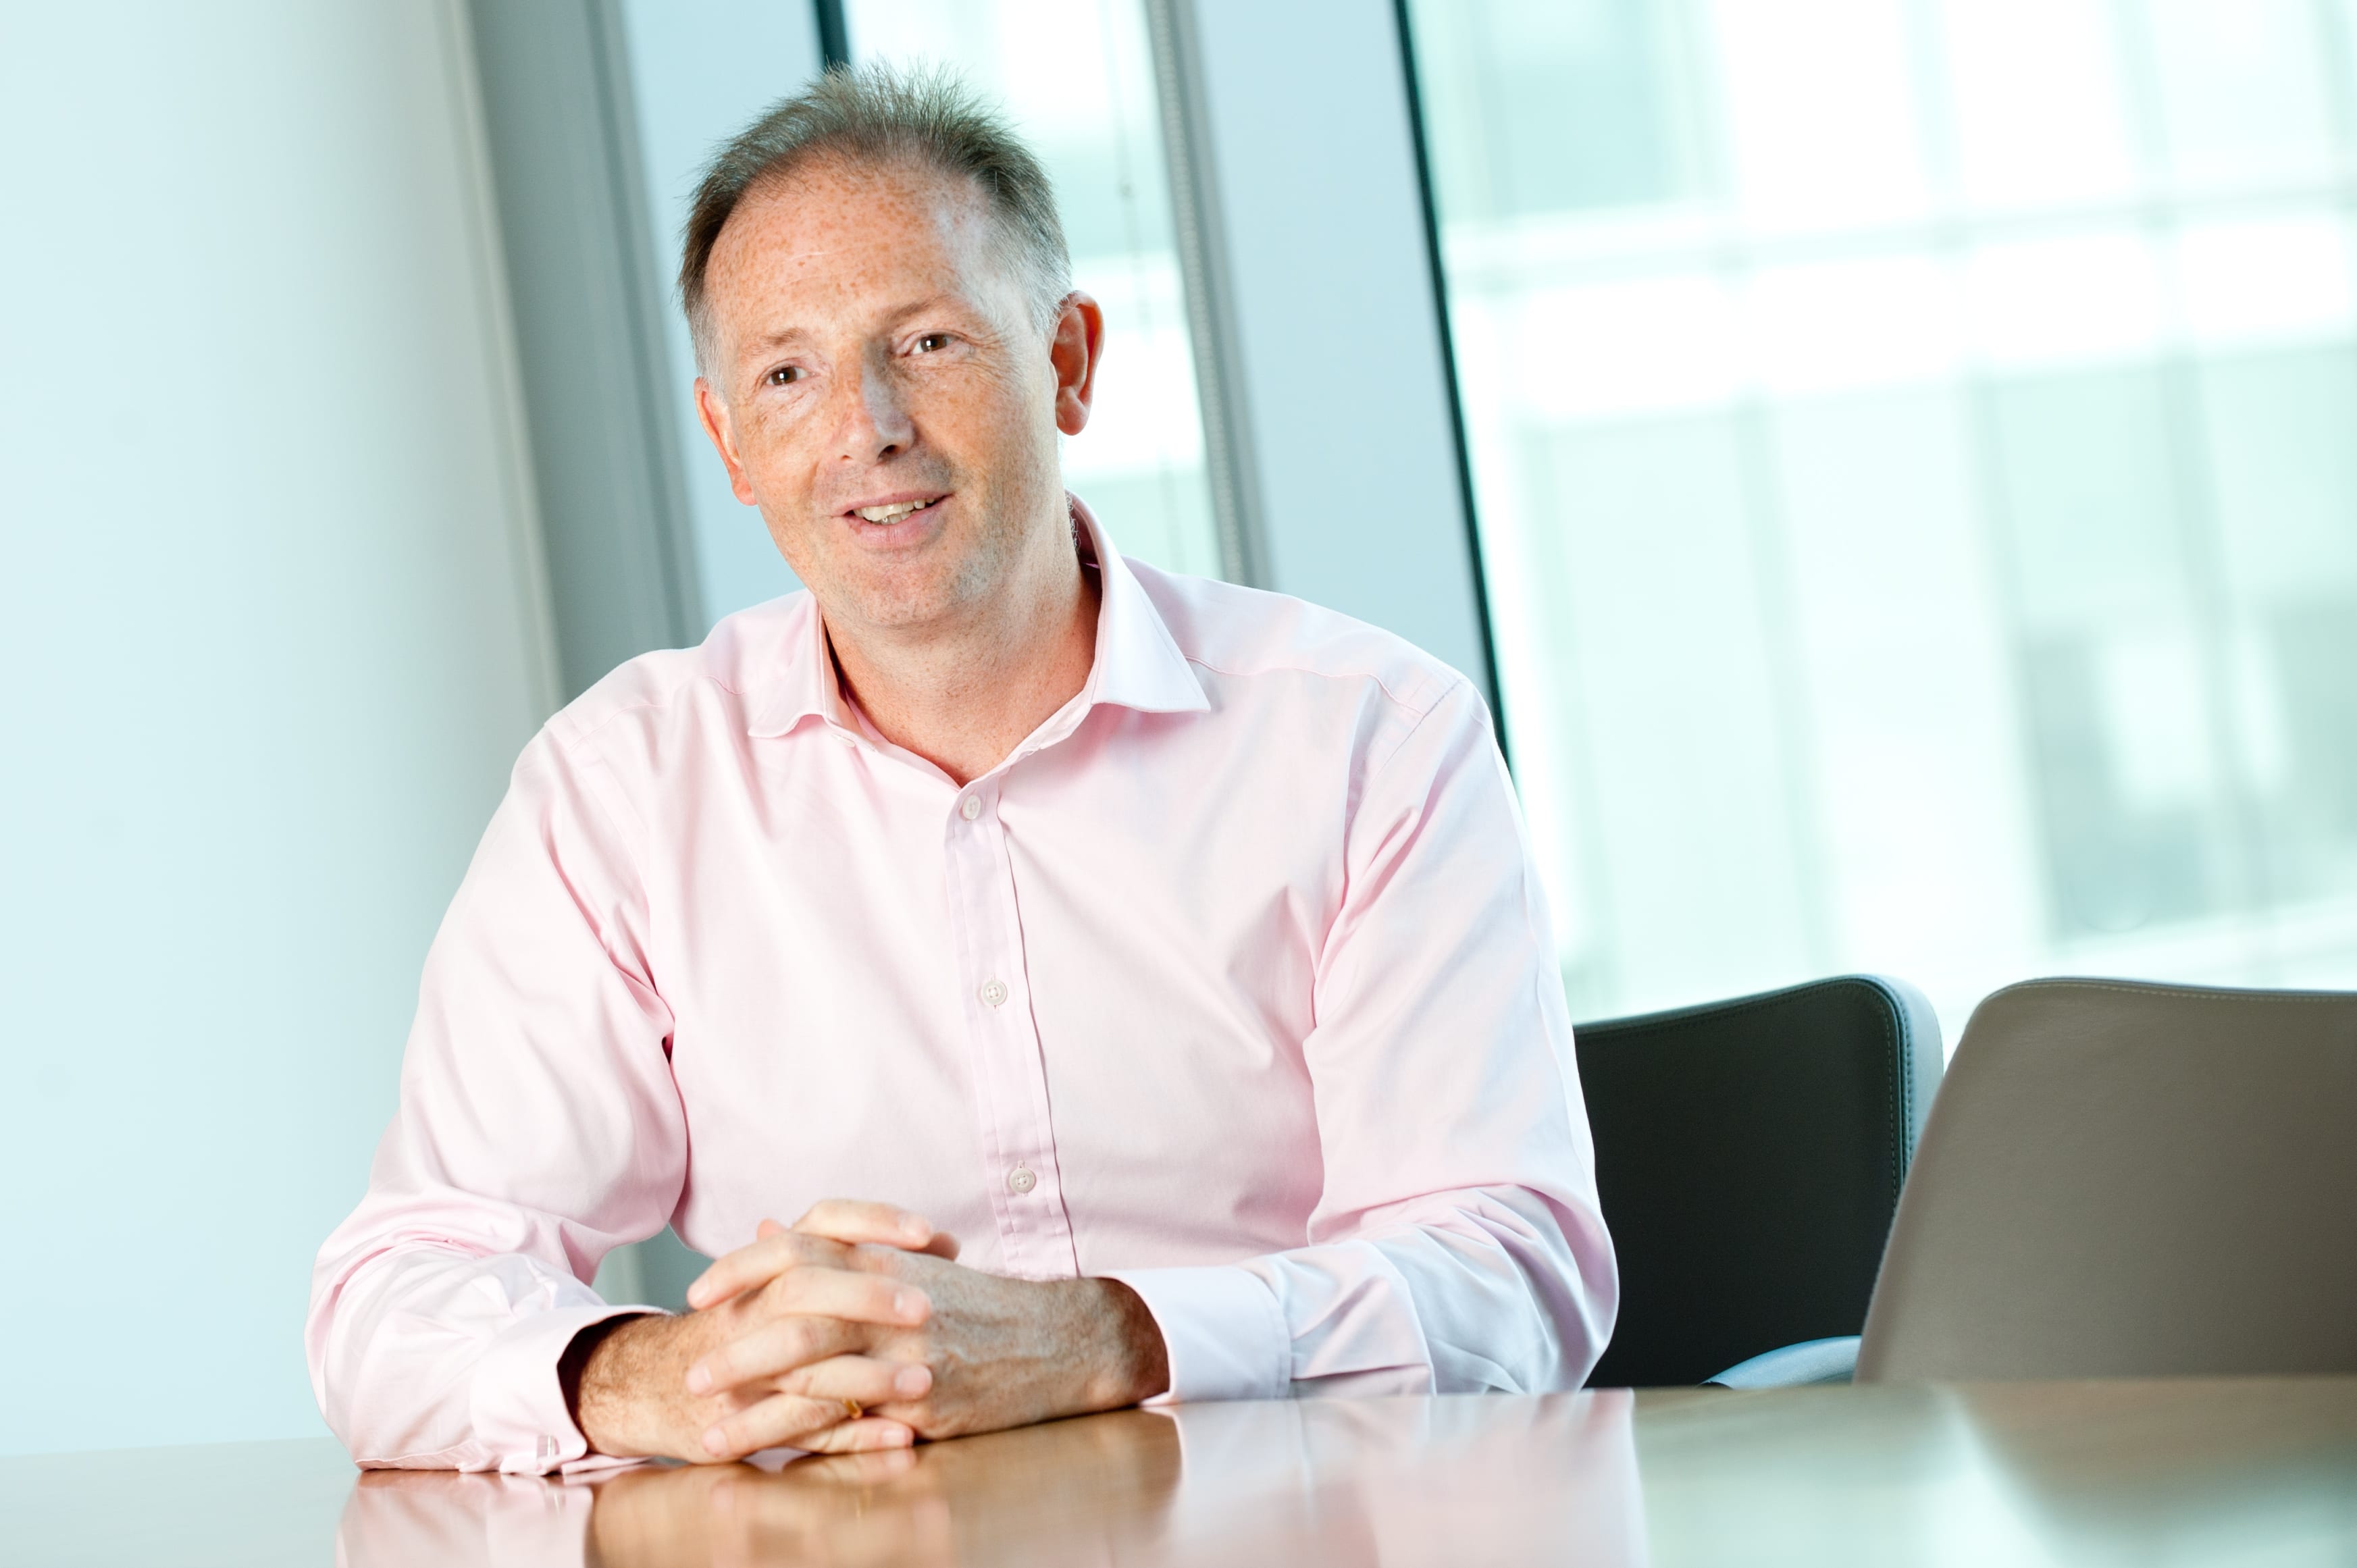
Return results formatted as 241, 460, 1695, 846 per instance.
844, 0, 1218, 575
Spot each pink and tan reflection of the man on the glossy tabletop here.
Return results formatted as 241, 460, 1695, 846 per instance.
342, 1391, 1643, 1568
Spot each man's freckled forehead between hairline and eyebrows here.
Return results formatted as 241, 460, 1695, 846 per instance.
705, 158, 995, 330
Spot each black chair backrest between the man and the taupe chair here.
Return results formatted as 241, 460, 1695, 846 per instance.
1572, 976, 1940, 1386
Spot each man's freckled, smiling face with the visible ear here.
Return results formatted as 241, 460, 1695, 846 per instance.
698, 158, 1101, 629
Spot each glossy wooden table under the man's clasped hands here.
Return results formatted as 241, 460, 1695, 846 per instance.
0, 1377, 2357, 1568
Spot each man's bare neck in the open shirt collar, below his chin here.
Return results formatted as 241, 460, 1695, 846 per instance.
821, 528, 1101, 785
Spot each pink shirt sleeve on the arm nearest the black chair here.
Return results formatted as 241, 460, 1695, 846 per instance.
1112, 681, 1620, 1401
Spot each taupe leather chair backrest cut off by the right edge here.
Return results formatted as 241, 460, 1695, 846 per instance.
1857, 981, 2357, 1382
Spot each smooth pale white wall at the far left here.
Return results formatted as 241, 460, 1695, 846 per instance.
0, 0, 552, 1453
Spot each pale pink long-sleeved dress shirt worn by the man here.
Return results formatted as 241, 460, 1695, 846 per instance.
307, 502, 1617, 1471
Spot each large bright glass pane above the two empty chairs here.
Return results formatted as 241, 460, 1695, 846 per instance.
1409, 0, 2357, 1040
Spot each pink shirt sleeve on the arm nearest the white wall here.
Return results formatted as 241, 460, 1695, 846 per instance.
304, 731, 686, 1473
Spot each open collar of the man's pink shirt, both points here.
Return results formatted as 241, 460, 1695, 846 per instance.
750, 495, 1212, 738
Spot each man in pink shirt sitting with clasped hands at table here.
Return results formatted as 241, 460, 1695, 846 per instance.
307, 73, 1615, 1471
